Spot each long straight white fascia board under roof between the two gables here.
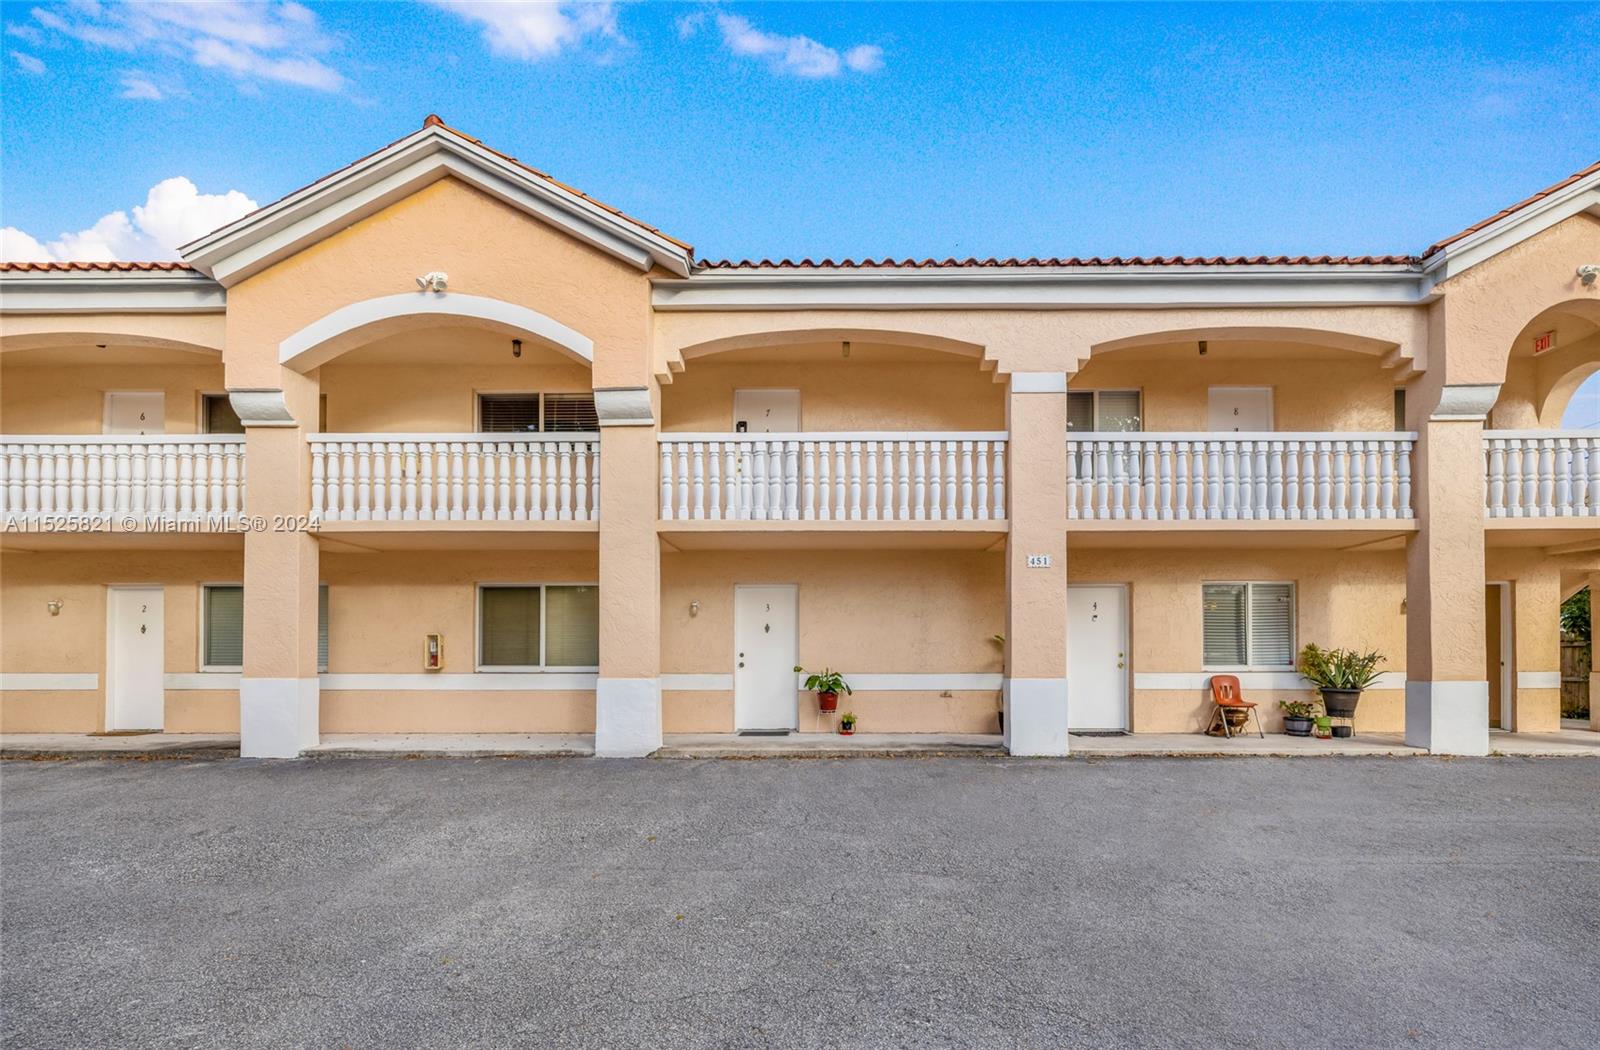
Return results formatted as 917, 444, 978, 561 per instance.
651, 267, 1426, 311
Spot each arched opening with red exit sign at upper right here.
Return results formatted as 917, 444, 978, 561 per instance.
1490, 299, 1600, 431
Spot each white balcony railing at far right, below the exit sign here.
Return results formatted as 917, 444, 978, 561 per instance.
1483, 431, 1600, 517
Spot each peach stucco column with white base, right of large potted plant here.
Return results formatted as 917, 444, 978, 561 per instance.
1405, 384, 1499, 755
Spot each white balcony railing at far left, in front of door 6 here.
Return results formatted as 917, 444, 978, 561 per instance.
0, 434, 245, 528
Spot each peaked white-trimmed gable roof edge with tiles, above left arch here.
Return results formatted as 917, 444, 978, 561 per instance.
179, 114, 694, 287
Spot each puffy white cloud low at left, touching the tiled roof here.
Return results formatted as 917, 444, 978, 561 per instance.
0, 177, 256, 263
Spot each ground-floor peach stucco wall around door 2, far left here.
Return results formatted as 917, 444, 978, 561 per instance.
0, 549, 243, 733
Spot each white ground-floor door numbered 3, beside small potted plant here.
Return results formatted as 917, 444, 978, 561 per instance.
733, 584, 800, 731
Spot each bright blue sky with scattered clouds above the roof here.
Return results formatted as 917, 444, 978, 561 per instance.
9, 2, 1600, 419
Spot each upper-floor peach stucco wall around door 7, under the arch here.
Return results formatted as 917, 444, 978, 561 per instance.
661, 355, 1005, 432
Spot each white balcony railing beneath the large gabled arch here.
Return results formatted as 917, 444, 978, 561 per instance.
309, 434, 600, 522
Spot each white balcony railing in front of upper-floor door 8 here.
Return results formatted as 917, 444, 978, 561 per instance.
1067, 432, 1416, 522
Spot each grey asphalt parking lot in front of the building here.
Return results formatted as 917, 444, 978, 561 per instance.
0, 759, 1600, 1048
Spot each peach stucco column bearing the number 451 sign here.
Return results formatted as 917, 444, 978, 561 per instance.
1003, 371, 1067, 755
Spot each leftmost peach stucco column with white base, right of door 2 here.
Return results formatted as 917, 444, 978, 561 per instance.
229, 370, 322, 759
